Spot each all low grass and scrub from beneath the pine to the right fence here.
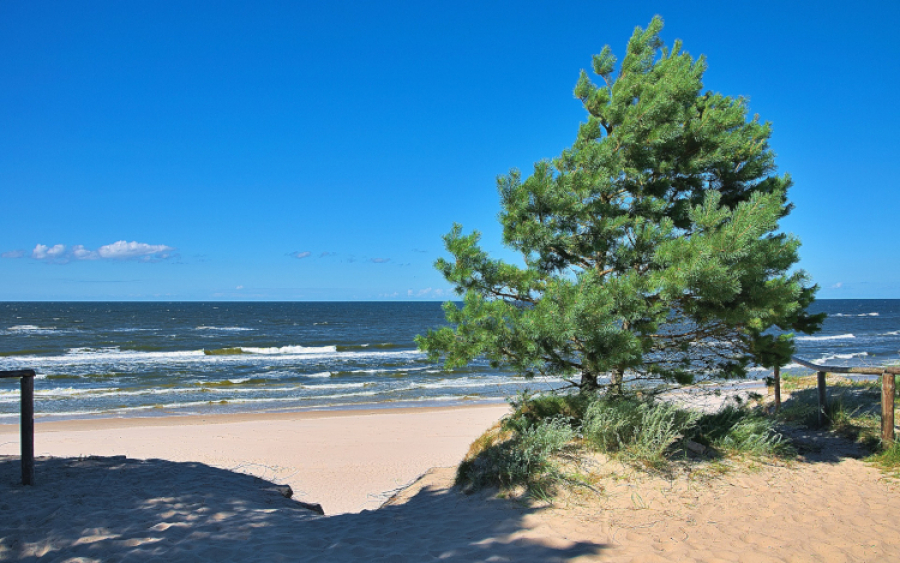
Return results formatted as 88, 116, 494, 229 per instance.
457, 376, 900, 498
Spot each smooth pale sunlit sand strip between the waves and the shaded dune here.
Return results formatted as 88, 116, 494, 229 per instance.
0, 405, 509, 514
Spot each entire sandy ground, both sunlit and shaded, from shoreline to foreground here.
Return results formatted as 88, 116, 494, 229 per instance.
0, 405, 900, 562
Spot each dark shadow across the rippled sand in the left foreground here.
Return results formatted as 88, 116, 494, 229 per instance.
0, 457, 606, 563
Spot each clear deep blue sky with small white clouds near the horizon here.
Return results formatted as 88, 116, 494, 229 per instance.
0, 0, 900, 300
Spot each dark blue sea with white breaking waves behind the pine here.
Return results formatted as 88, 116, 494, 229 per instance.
0, 300, 900, 423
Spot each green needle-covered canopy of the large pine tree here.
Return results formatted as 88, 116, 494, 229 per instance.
418, 16, 821, 392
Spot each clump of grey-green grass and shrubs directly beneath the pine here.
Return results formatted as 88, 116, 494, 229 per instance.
457, 393, 791, 496
